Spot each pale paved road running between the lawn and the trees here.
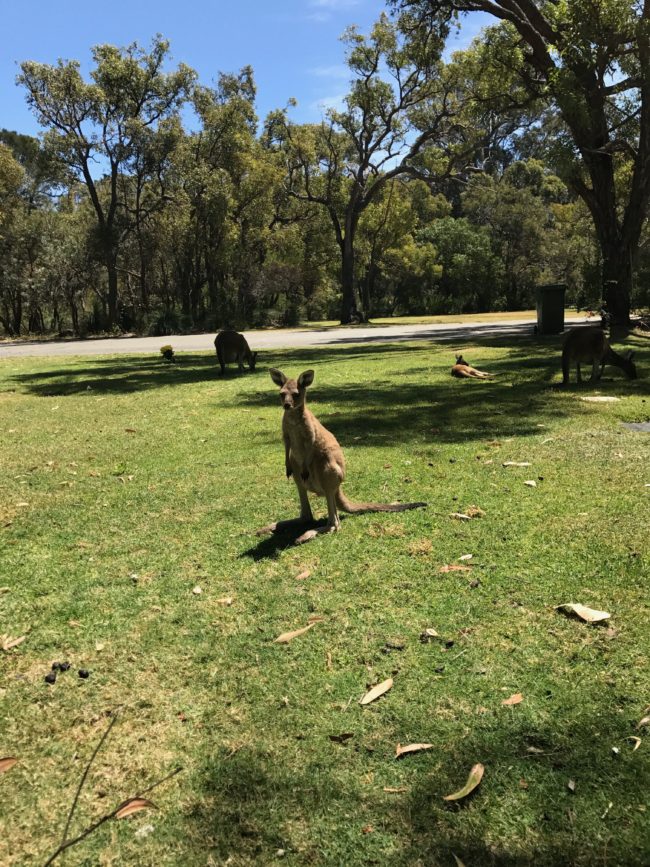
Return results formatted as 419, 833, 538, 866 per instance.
0, 318, 588, 360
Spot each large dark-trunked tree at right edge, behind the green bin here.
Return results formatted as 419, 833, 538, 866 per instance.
391, 0, 650, 324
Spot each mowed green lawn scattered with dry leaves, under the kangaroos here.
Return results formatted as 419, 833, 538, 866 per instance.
0, 336, 650, 867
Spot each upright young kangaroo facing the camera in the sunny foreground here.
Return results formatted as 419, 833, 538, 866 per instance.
258, 368, 427, 545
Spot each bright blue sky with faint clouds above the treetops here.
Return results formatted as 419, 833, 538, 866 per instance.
0, 0, 486, 135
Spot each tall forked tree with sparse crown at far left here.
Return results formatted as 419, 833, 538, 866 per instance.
18, 36, 195, 328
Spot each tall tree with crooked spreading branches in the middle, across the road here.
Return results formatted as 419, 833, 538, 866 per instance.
266, 15, 474, 323
